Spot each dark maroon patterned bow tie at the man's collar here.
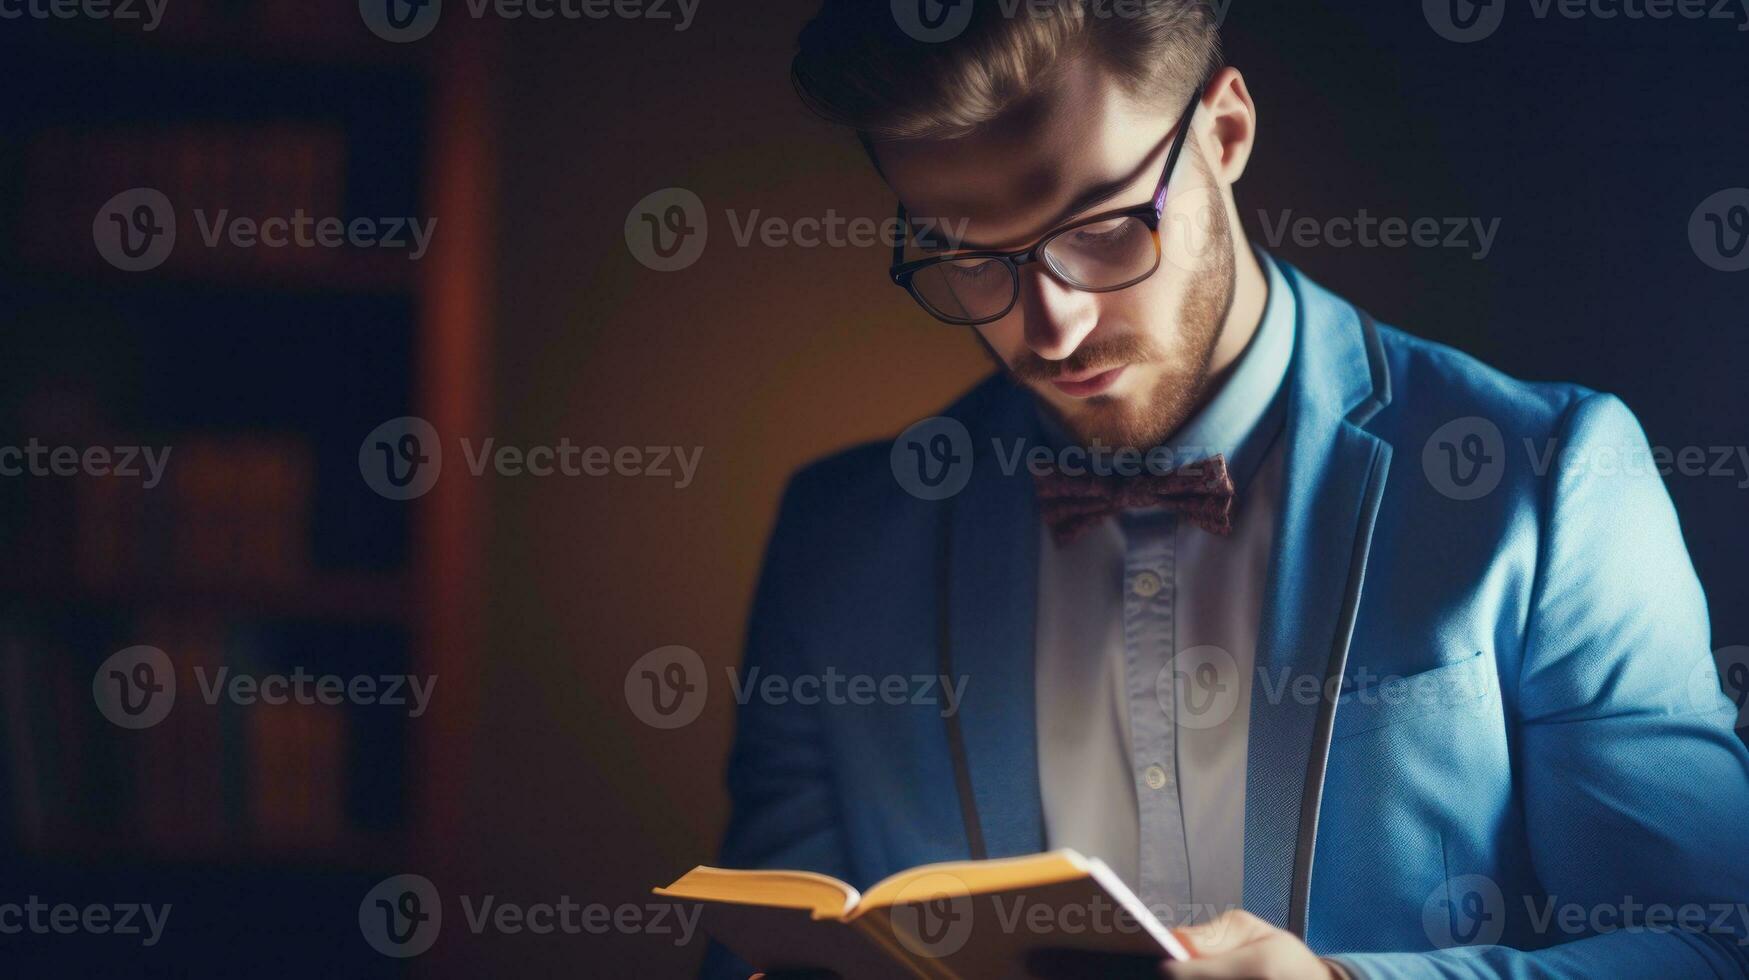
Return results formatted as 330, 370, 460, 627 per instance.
1034, 453, 1235, 546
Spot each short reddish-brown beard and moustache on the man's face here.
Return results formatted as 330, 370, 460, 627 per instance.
985, 167, 1237, 452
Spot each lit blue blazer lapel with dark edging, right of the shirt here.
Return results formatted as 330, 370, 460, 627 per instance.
1244, 264, 1390, 936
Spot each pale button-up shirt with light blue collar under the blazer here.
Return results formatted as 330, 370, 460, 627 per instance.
1037, 252, 1298, 926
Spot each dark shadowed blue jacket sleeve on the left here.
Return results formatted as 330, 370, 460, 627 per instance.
703, 469, 850, 980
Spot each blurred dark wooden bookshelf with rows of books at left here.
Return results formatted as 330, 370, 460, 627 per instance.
0, 0, 491, 966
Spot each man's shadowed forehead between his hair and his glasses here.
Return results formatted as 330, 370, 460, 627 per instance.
875, 60, 1172, 247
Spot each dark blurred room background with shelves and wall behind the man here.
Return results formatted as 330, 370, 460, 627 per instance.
0, 0, 1749, 977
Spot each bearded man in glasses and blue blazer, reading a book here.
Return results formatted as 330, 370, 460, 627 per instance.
714, 0, 1749, 978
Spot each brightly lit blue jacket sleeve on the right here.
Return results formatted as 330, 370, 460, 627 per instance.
1334, 396, 1749, 978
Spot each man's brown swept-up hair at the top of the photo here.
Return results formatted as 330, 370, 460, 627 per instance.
791, 0, 1221, 142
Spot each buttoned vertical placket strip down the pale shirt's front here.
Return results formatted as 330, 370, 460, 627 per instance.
1123, 511, 1191, 924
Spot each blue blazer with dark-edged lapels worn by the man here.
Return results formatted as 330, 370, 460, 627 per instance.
707, 264, 1749, 978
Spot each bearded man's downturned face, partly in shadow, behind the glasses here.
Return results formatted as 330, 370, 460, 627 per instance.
875, 60, 1233, 448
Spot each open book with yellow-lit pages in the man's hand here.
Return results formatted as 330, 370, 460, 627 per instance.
654, 851, 1189, 980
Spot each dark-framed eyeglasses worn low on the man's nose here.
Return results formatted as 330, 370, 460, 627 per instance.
892, 86, 1203, 327
